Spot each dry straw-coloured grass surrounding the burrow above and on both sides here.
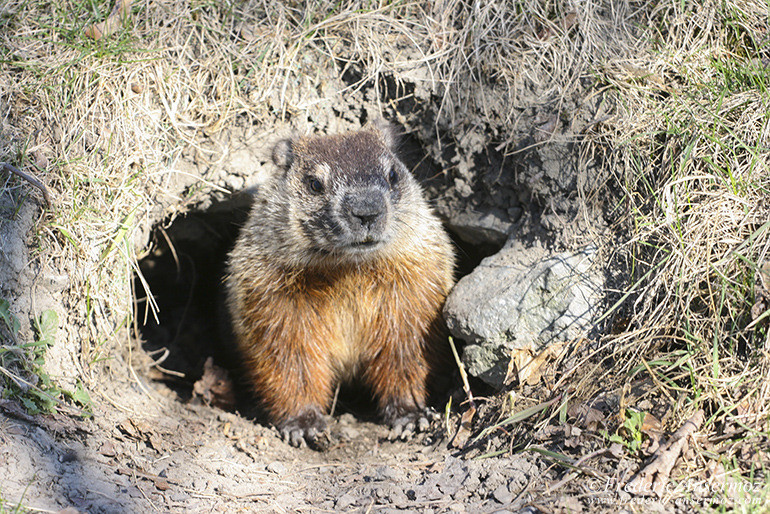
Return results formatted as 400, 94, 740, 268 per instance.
0, 0, 770, 504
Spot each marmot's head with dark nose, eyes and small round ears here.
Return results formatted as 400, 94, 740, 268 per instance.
273, 125, 414, 260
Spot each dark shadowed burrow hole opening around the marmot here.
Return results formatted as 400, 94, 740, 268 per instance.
134, 142, 500, 419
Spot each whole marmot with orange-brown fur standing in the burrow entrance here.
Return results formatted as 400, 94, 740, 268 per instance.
225, 122, 455, 446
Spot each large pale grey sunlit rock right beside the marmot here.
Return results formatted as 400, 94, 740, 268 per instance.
444, 242, 604, 387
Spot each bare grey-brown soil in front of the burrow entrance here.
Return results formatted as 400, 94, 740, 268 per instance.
0, 358, 564, 512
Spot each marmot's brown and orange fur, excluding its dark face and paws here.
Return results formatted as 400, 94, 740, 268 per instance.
227, 121, 454, 440
